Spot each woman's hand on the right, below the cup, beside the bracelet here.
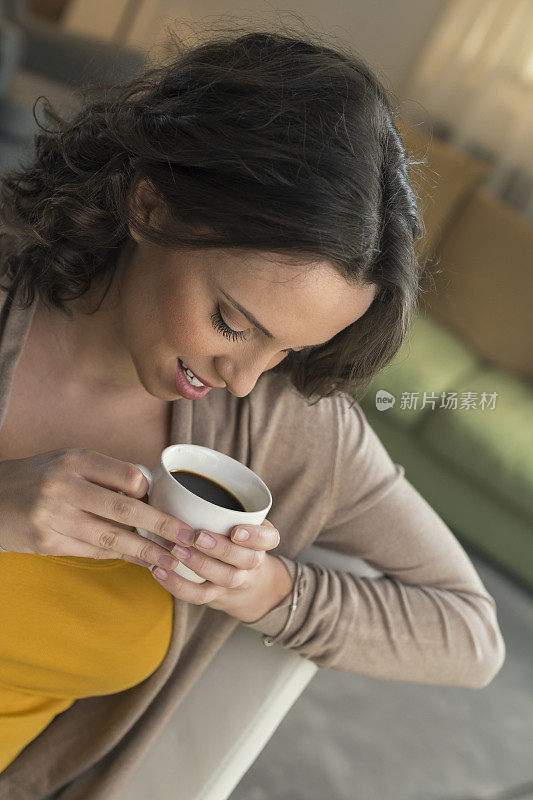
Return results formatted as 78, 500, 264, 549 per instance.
152, 520, 282, 621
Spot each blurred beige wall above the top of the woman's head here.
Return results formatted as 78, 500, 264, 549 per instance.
64, 0, 448, 96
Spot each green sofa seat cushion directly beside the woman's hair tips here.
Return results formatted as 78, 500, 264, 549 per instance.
361, 311, 479, 428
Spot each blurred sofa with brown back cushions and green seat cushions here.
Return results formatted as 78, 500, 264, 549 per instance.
361, 122, 533, 587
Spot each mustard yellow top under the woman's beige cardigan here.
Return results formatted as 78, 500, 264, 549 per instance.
0, 552, 174, 771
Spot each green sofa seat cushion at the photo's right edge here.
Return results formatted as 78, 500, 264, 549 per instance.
418, 364, 533, 520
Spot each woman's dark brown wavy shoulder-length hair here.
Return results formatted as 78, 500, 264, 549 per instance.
0, 20, 424, 400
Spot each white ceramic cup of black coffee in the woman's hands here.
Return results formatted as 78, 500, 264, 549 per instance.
135, 444, 272, 583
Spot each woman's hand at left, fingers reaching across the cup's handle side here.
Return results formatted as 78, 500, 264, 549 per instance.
0, 447, 192, 568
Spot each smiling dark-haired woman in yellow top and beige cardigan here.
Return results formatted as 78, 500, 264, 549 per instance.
0, 23, 505, 800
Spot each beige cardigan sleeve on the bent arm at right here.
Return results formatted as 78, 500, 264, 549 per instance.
239, 394, 506, 689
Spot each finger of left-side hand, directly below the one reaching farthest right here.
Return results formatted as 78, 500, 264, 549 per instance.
49, 507, 178, 568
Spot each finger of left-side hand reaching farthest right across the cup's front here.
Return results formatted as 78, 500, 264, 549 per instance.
64, 479, 193, 555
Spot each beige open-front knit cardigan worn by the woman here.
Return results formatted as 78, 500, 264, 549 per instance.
0, 278, 505, 800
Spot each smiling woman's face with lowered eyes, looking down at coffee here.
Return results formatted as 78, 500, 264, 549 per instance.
112, 181, 377, 400
